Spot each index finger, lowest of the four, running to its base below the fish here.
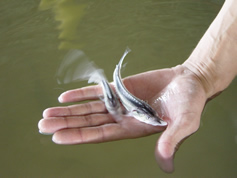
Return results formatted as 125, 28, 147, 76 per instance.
53, 116, 167, 144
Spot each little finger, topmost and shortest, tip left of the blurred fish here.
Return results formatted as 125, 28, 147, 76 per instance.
58, 85, 103, 103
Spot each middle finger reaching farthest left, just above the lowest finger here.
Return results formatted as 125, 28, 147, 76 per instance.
38, 114, 114, 134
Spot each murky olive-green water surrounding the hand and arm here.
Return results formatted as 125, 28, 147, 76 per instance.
0, 0, 237, 177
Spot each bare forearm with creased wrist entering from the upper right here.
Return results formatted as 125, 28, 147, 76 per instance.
183, 0, 237, 98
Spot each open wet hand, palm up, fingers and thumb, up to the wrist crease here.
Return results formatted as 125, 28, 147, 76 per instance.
39, 65, 207, 172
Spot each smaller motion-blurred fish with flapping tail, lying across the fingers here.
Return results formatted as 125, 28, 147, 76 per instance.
56, 49, 123, 115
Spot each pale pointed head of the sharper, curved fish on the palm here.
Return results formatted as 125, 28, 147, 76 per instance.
132, 108, 167, 126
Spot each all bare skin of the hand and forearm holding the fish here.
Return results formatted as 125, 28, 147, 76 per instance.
38, 0, 237, 172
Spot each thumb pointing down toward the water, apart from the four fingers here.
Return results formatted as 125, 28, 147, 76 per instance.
155, 115, 199, 173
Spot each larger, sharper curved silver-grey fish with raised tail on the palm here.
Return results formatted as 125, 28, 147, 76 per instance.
113, 48, 167, 126
